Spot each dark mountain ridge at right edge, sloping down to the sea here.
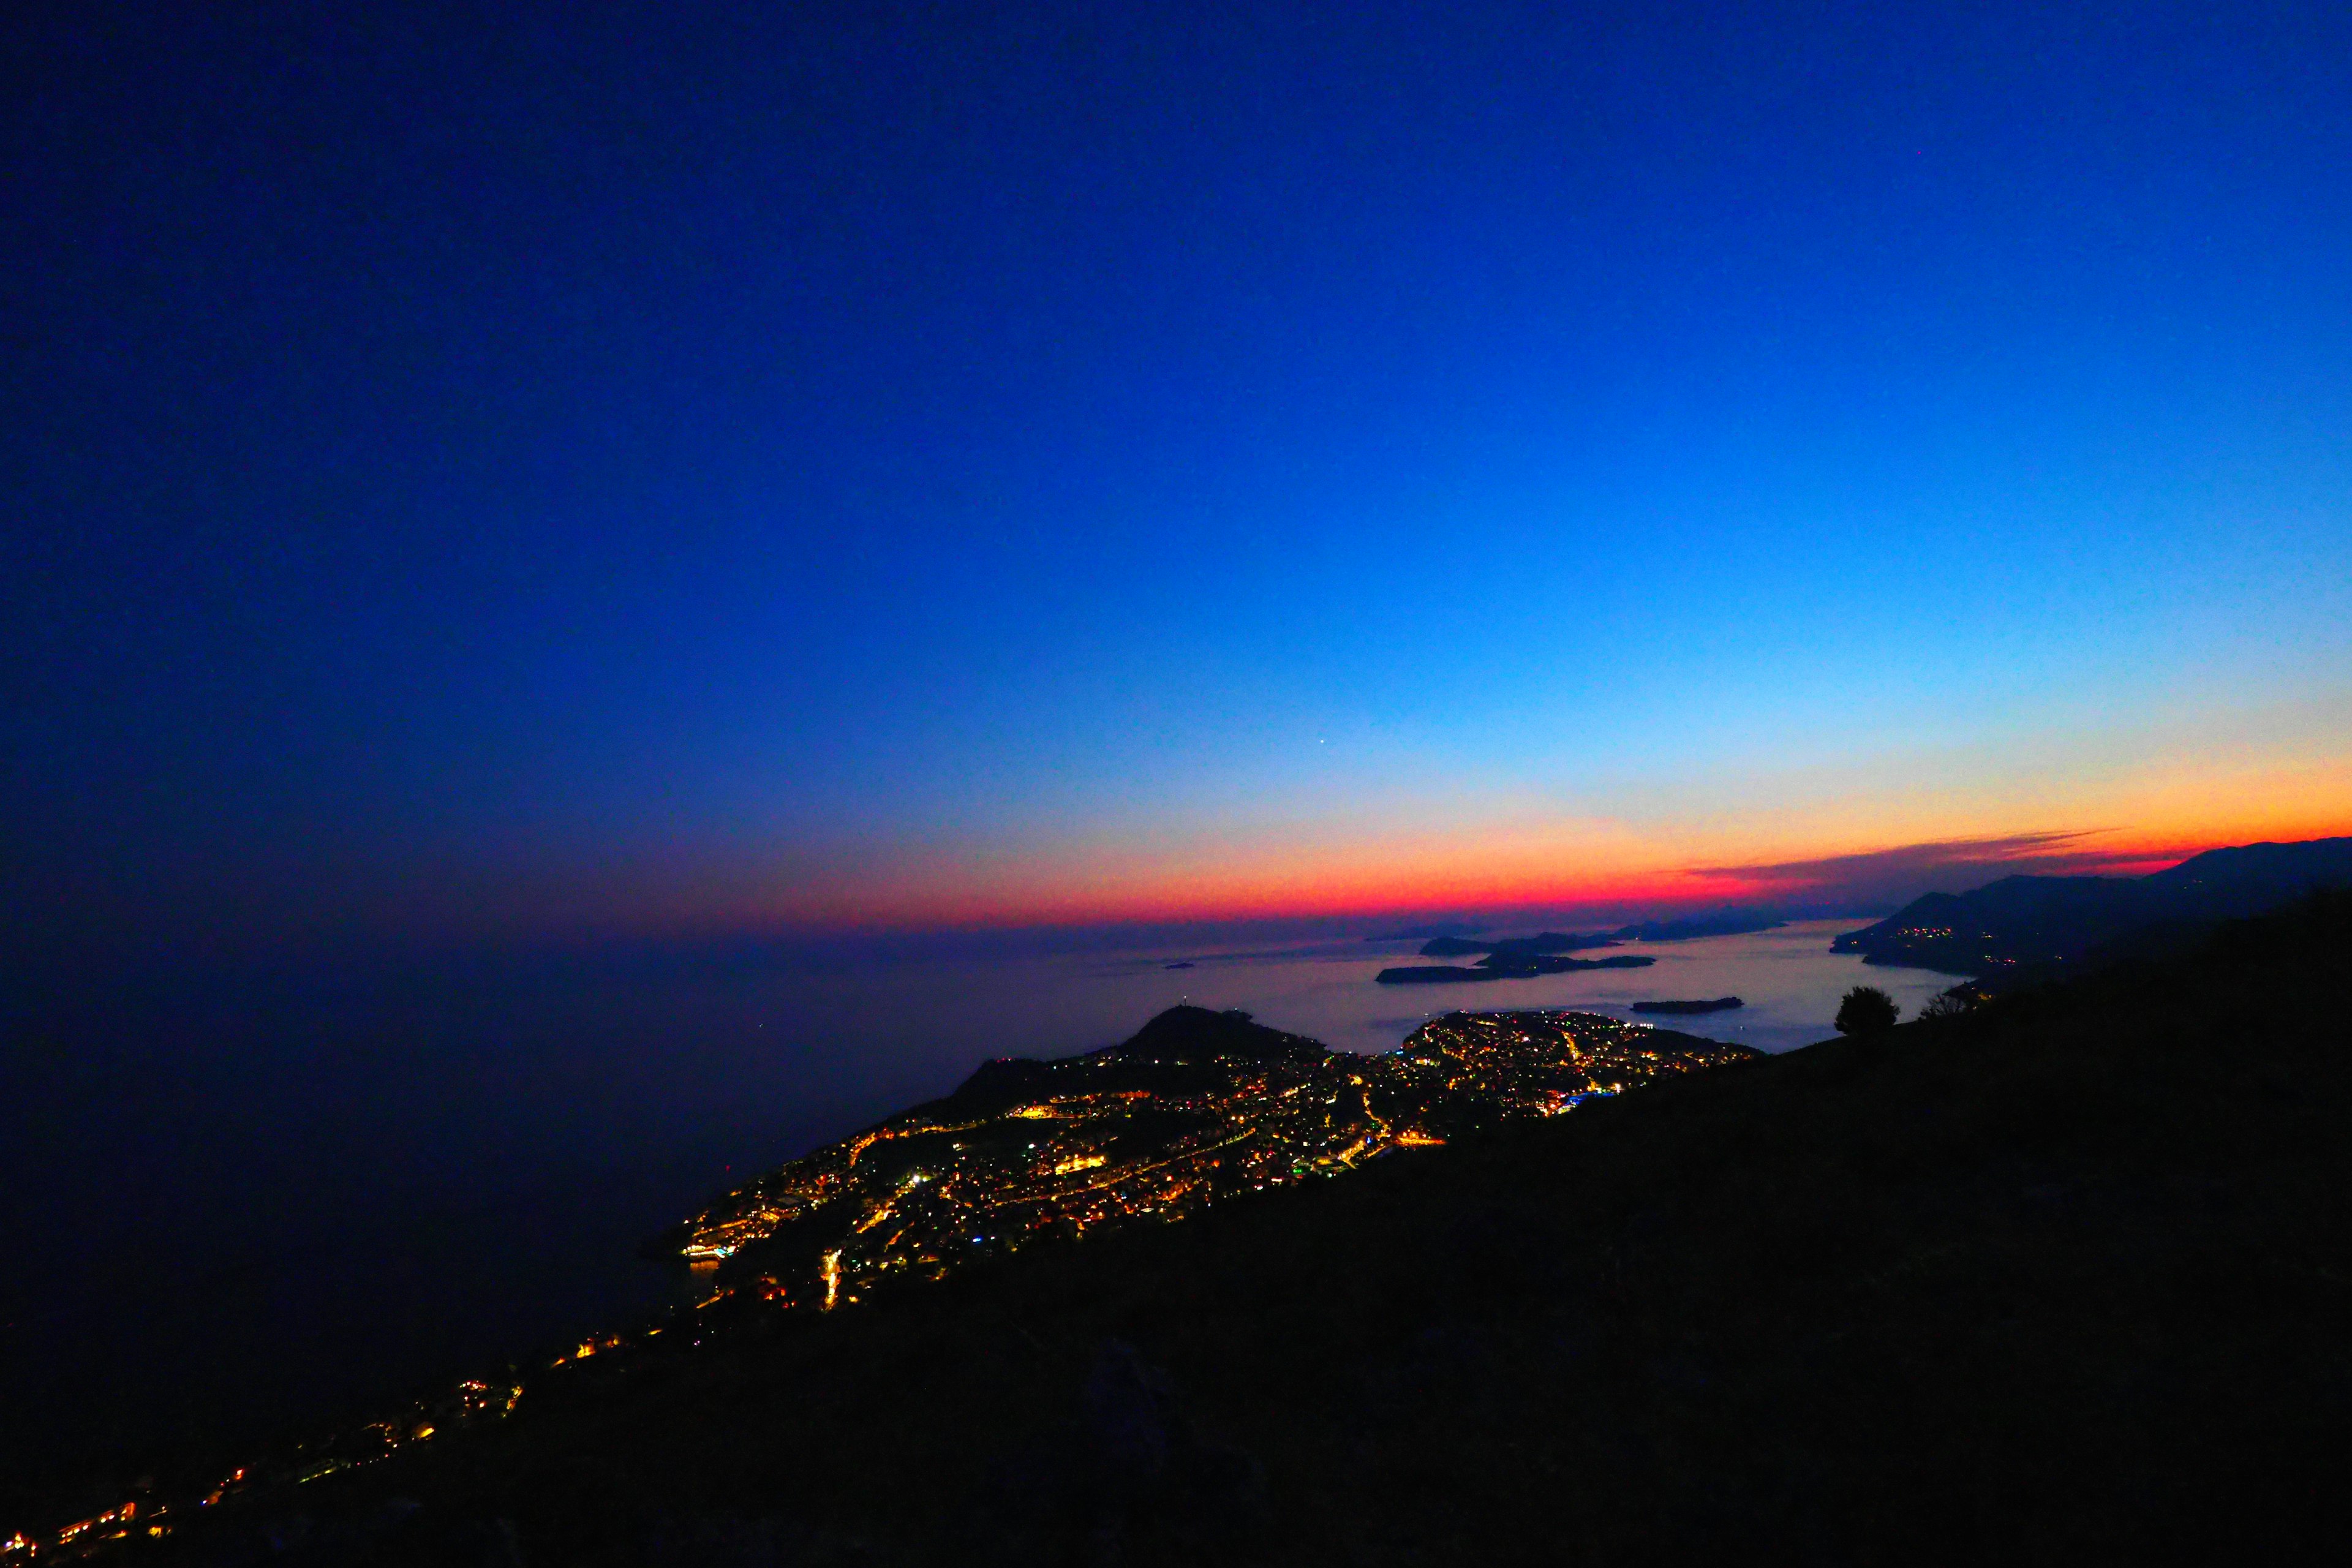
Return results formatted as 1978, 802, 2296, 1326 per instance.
1832, 839, 2352, 976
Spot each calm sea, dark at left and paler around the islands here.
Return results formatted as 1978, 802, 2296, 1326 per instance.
0, 922, 1950, 1528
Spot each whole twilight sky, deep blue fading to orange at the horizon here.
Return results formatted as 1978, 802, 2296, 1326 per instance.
0, 2, 2352, 950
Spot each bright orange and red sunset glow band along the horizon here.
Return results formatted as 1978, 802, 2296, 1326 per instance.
706, 698, 2352, 931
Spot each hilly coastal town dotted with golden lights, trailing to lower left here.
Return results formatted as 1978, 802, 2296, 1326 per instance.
0, 1006, 1757, 1563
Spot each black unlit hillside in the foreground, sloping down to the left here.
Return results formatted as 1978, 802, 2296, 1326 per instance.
132, 898, 2352, 1568
